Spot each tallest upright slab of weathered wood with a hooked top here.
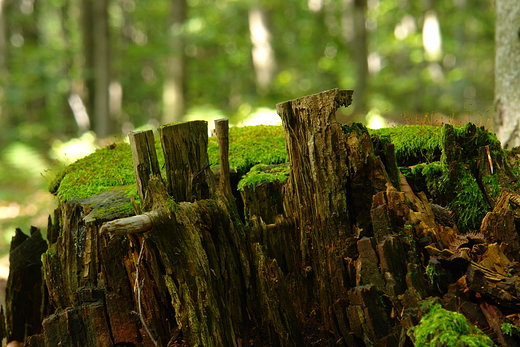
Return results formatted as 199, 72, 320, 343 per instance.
276, 89, 362, 339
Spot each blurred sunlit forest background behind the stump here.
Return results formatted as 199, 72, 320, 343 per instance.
0, 0, 494, 262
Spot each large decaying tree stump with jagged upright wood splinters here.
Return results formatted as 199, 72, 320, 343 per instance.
6, 89, 520, 346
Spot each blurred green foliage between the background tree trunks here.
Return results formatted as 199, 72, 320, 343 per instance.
0, 0, 494, 139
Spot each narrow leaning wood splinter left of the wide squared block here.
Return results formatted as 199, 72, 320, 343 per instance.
128, 130, 161, 207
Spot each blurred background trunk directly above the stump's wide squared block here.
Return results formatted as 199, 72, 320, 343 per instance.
162, 0, 187, 124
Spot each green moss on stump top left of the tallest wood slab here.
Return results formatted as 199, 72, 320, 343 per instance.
49, 126, 287, 207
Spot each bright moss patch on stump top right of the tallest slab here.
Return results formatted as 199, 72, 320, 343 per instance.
369, 125, 443, 166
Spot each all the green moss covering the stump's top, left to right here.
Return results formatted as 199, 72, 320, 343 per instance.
50, 123, 517, 234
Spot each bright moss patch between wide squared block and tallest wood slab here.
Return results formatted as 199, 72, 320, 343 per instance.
208, 125, 288, 174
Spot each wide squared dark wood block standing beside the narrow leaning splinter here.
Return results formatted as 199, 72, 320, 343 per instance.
159, 121, 215, 202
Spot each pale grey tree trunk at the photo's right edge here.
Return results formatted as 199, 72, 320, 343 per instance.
495, 0, 520, 148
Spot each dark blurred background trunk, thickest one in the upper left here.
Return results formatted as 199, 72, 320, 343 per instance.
82, 0, 115, 138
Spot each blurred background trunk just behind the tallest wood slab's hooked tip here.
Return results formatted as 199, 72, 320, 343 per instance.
342, 0, 368, 114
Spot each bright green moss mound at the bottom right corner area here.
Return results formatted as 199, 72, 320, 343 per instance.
408, 304, 495, 347
